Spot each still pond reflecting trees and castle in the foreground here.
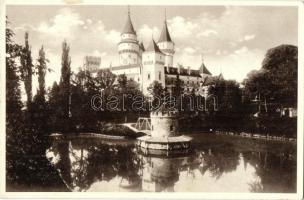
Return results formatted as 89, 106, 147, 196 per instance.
46, 134, 296, 192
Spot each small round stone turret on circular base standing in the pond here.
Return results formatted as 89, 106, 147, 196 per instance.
137, 104, 192, 153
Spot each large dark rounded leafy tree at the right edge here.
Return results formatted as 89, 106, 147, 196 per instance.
244, 45, 298, 111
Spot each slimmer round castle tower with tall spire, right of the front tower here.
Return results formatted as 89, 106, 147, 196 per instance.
157, 10, 175, 67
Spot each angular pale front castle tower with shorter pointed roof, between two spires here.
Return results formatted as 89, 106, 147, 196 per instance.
142, 38, 165, 95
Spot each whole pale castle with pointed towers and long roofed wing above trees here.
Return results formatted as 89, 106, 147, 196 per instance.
105, 7, 222, 96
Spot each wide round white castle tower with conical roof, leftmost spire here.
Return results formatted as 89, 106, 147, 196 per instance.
118, 7, 141, 65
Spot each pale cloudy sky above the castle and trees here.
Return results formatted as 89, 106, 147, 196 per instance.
6, 5, 298, 90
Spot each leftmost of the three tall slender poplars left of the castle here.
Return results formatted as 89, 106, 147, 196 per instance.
20, 32, 34, 109
